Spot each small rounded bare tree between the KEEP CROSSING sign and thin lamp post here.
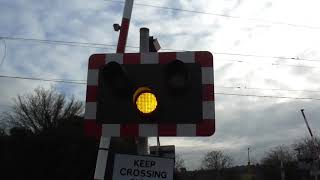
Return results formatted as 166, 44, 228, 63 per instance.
202, 151, 233, 171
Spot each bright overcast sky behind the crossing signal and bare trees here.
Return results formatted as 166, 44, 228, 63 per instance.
0, 0, 320, 169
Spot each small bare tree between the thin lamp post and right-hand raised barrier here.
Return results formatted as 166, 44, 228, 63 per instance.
261, 145, 295, 166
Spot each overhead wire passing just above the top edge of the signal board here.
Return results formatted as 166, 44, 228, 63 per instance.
0, 36, 320, 62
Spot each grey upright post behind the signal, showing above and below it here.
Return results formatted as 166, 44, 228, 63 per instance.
137, 28, 149, 155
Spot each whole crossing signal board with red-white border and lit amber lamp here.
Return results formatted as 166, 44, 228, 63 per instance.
85, 51, 215, 137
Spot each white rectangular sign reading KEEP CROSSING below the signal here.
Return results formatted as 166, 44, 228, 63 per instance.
112, 154, 174, 180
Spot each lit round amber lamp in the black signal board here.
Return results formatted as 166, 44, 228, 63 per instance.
136, 92, 158, 114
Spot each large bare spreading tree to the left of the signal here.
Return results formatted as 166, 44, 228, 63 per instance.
3, 88, 83, 134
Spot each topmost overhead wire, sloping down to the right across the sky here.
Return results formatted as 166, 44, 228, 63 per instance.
105, 0, 320, 29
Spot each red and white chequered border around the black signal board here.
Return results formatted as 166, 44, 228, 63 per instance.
85, 51, 215, 138
